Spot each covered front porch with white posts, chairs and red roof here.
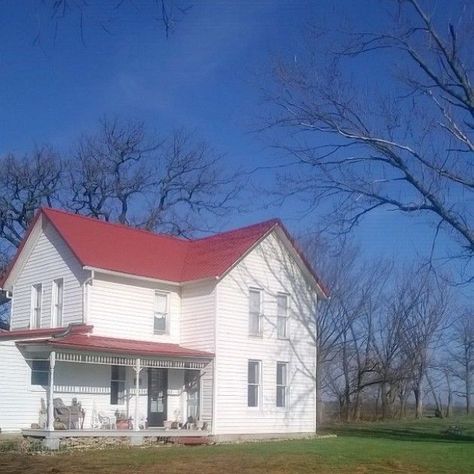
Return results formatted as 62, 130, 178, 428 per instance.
16, 326, 212, 444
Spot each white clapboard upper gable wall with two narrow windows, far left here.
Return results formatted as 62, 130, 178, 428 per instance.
11, 221, 85, 329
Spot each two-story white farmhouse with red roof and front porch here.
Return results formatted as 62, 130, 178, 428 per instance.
0, 209, 326, 444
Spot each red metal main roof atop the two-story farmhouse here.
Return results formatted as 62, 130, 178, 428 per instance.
0, 208, 327, 294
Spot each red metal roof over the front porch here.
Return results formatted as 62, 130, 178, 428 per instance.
21, 334, 214, 359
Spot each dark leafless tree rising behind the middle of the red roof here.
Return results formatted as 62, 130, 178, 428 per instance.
67, 120, 239, 235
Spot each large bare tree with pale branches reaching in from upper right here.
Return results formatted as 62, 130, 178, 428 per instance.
264, 0, 474, 281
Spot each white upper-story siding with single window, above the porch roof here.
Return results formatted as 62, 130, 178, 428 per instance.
87, 272, 181, 343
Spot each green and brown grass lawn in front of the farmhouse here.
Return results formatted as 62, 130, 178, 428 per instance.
0, 418, 474, 474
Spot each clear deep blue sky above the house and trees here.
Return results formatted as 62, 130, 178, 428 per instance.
0, 0, 466, 282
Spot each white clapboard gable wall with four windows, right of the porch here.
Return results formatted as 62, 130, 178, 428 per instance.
215, 234, 316, 434
